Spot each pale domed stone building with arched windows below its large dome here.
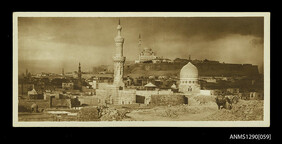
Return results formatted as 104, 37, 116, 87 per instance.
179, 62, 200, 93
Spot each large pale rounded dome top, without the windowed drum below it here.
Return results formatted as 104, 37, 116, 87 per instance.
180, 62, 198, 79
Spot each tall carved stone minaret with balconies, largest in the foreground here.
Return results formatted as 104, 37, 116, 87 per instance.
113, 20, 125, 87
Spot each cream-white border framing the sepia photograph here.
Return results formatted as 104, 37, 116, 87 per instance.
13, 12, 270, 127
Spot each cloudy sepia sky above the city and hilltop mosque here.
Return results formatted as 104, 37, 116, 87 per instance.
18, 17, 264, 74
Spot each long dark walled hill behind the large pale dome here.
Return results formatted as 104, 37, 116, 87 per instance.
124, 62, 259, 77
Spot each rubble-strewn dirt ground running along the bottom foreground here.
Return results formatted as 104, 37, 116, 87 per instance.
19, 96, 263, 121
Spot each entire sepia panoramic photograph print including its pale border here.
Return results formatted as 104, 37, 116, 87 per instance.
13, 12, 270, 127
